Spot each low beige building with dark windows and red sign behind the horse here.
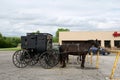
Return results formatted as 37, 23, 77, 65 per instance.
59, 31, 120, 47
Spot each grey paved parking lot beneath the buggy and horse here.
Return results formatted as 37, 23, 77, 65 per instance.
0, 51, 120, 80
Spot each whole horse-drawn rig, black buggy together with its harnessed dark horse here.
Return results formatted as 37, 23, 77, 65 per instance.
12, 33, 99, 69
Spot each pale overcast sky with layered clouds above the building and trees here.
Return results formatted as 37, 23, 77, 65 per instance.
0, 0, 120, 36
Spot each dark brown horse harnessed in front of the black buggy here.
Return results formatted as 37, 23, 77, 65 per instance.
59, 40, 100, 68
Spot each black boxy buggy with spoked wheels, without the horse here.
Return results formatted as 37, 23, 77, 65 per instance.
12, 33, 58, 68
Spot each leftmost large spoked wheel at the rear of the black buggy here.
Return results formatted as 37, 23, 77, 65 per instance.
12, 50, 30, 68
